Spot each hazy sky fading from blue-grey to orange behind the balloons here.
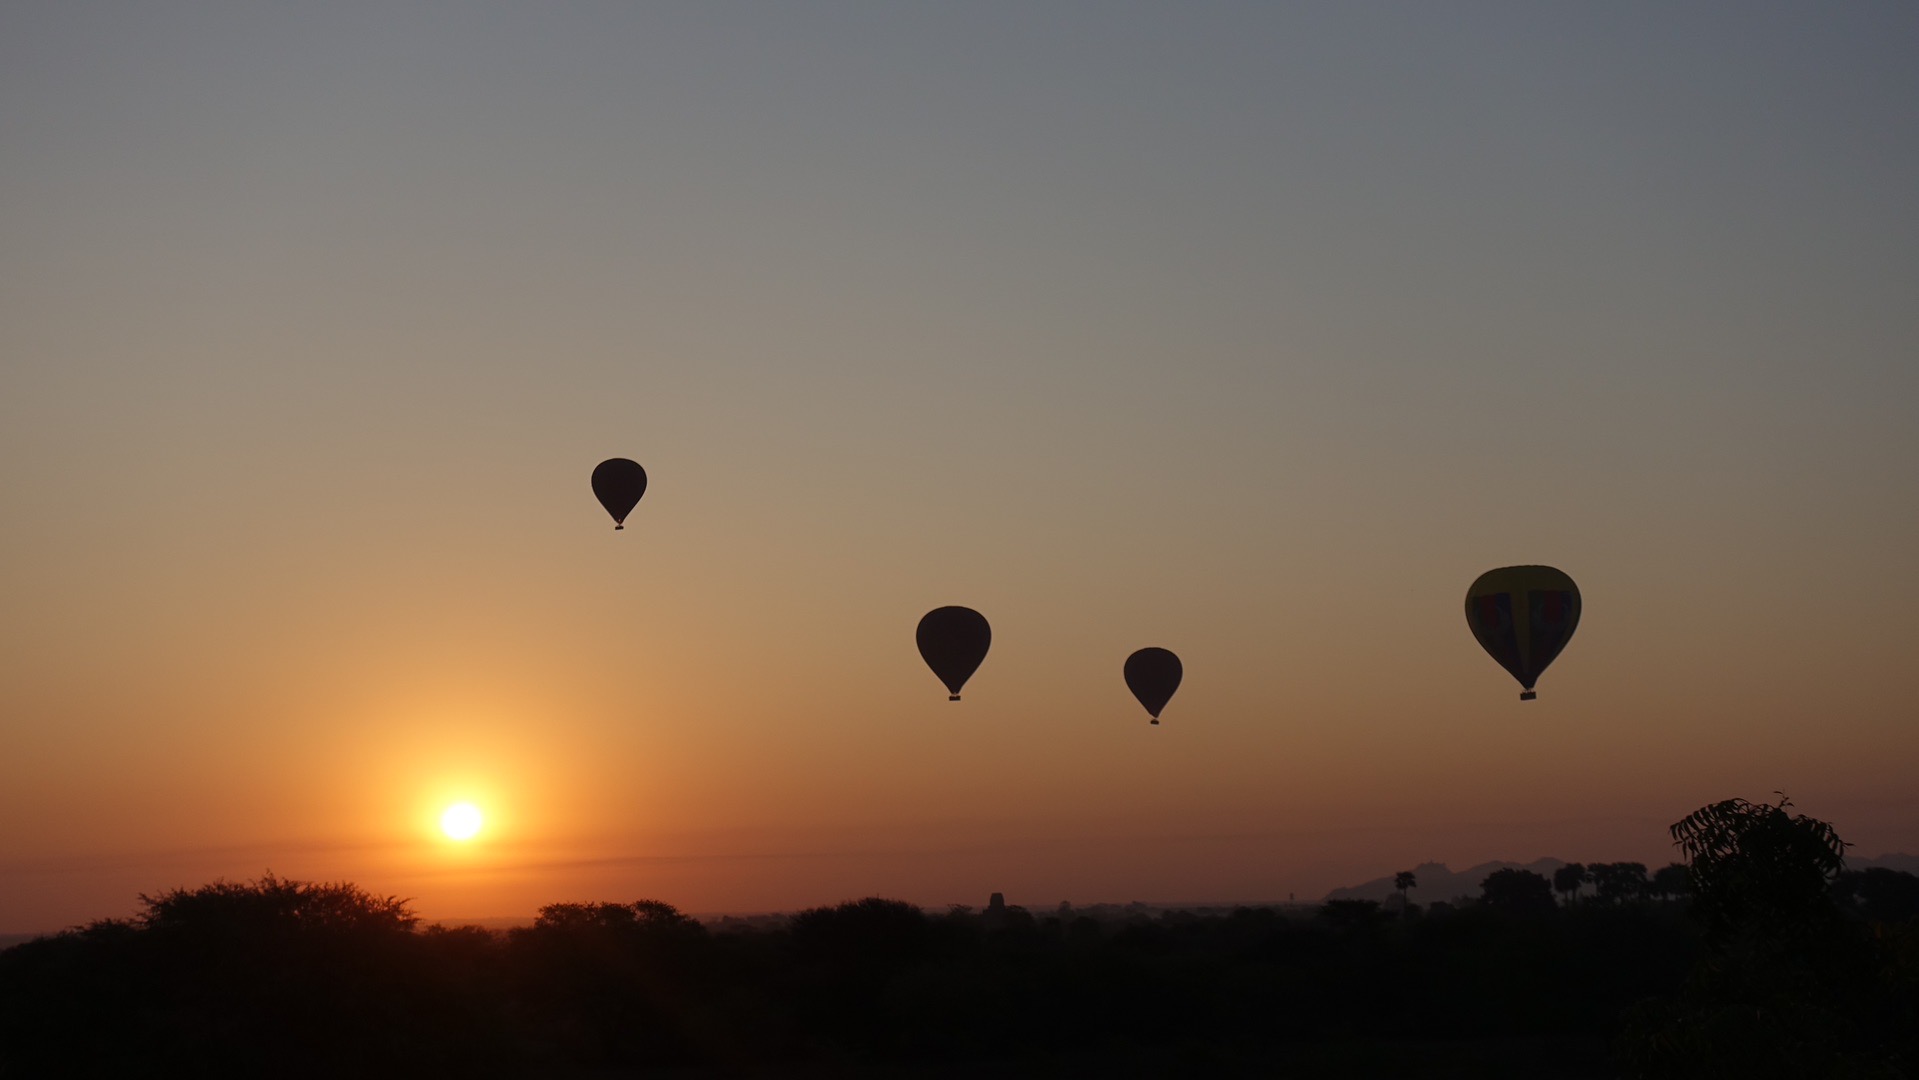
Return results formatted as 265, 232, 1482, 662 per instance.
0, 0, 1919, 930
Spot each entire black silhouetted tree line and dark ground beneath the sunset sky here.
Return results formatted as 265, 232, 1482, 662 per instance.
0, 800, 1919, 1078
